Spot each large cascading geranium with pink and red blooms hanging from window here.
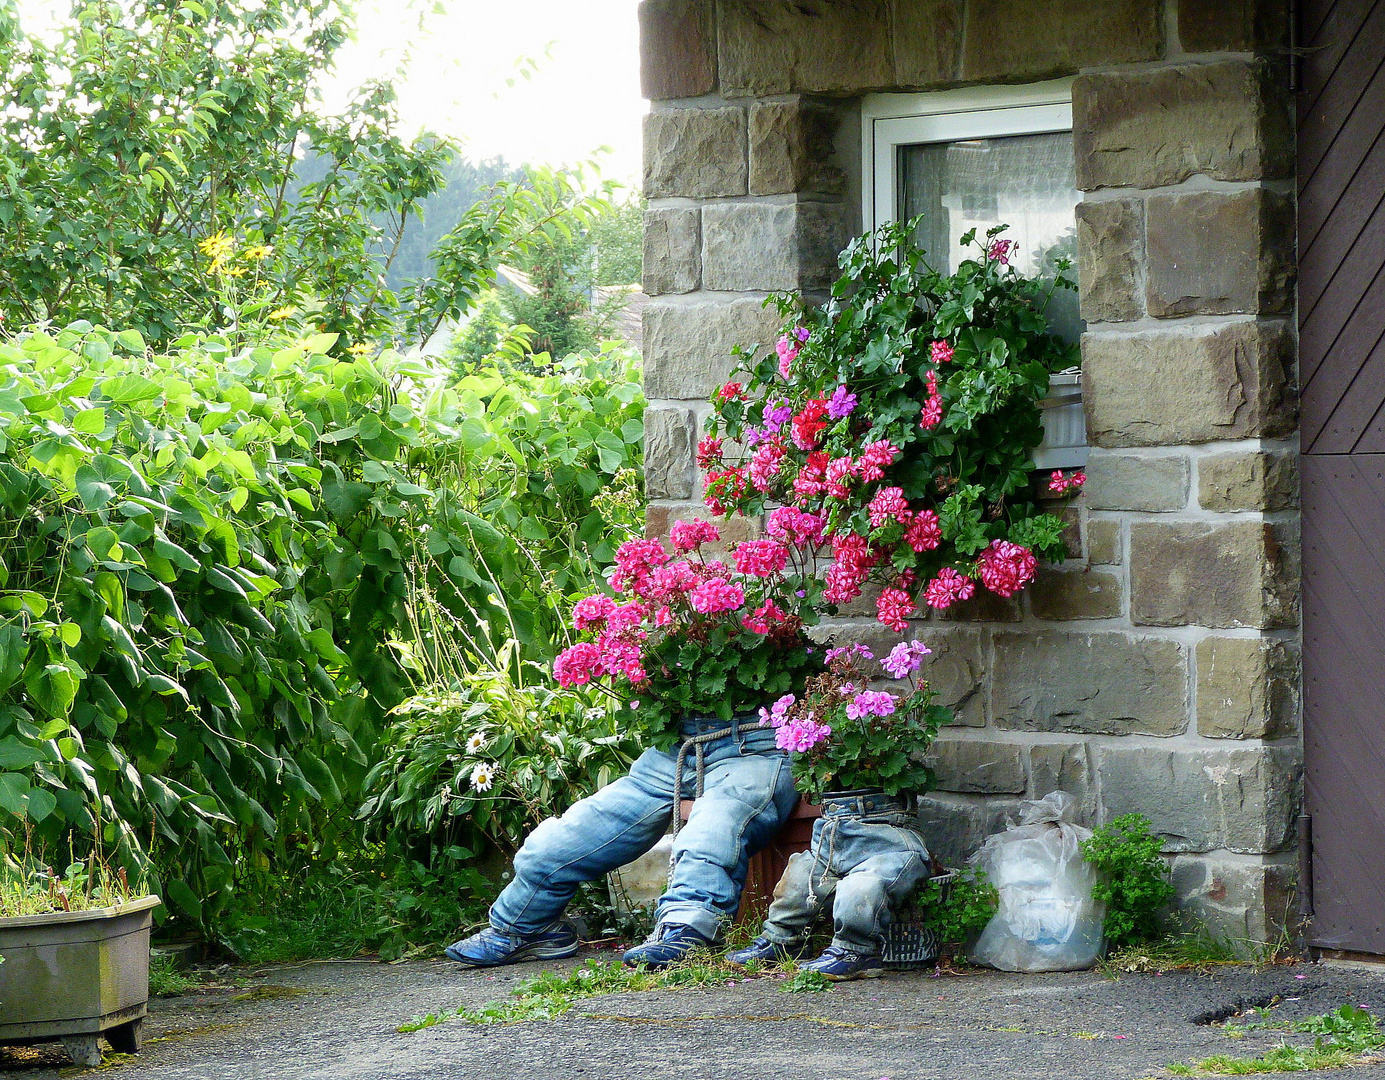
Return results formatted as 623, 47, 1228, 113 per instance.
698, 222, 1084, 631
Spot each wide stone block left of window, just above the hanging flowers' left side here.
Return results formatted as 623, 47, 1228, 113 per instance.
702, 201, 849, 292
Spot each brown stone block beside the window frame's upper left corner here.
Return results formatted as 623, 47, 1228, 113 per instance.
749, 98, 846, 195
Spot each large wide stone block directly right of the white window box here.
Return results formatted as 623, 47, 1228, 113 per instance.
1082, 321, 1296, 447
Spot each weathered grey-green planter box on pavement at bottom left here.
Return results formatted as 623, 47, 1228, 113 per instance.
0, 896, 159, 1066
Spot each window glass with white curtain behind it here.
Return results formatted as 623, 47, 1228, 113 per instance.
899, 132, 1083, 341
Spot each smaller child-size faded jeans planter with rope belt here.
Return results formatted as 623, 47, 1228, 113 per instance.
762, 795, 929, 955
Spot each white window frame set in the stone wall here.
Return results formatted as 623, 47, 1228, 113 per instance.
861, 79, 1072, 233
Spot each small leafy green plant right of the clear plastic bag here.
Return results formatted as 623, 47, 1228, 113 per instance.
1082, 814, 1173, 948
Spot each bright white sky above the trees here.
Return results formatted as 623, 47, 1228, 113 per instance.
19, 0, 647, 184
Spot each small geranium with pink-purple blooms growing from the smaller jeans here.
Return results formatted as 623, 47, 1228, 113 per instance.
760, 641, 951, 799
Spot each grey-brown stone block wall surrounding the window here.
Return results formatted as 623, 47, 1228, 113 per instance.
640, 0, 1301, 940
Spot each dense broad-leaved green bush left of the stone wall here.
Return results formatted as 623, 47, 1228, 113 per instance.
0, 323, 643, 921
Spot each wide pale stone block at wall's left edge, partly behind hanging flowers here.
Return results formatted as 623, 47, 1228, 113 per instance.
644, 296, 780, 400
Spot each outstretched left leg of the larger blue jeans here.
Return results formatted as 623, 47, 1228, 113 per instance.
490, 750, 673, 935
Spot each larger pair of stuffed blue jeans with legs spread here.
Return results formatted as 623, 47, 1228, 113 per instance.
490, 716, 798, 939
